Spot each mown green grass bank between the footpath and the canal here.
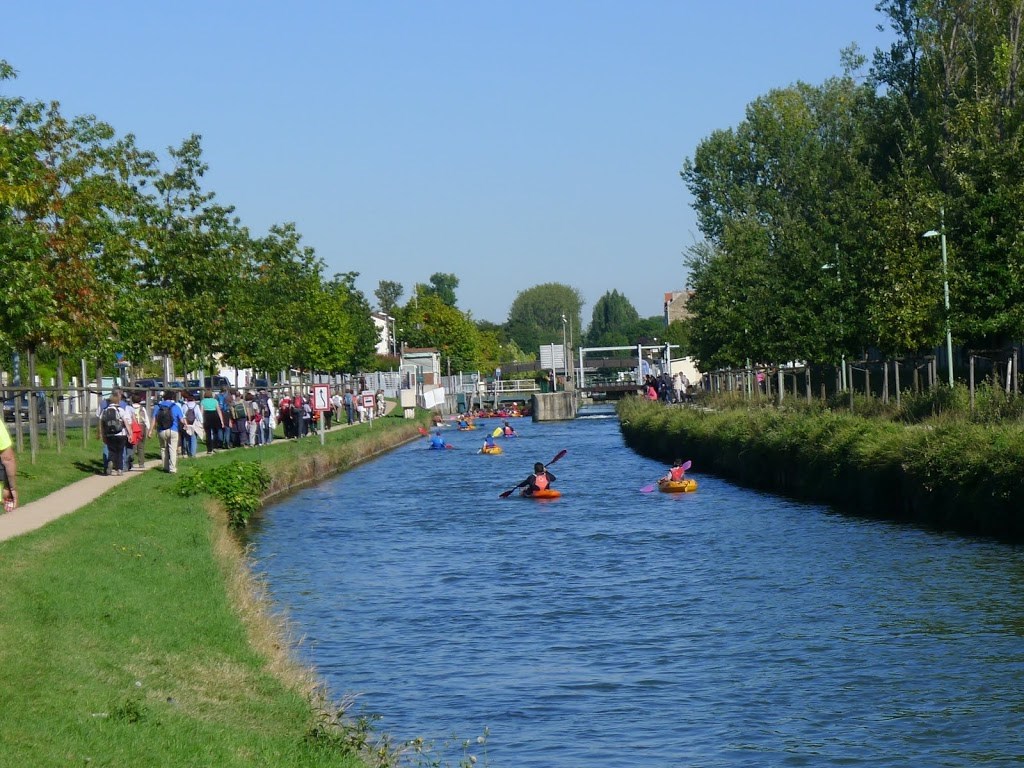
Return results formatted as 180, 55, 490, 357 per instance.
0, 418, 418, 768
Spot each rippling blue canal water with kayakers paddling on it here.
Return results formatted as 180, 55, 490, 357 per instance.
252, 410, 1024, 768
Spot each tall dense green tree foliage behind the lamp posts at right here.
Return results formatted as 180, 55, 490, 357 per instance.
682, 0, 1024, 366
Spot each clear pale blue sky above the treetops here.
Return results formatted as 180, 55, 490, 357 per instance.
0, 0, 889, 323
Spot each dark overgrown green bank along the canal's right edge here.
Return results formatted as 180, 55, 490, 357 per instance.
618, 398, 1024, 541
